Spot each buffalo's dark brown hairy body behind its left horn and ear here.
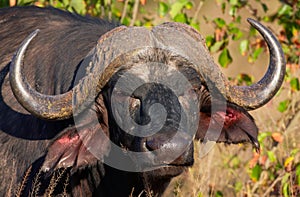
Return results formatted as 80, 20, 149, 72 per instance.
0, 7, 116, 196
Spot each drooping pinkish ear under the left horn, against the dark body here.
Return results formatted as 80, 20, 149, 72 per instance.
42, 97, 110, 171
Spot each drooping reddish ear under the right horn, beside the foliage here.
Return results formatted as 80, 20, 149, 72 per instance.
196, 103, 259, 149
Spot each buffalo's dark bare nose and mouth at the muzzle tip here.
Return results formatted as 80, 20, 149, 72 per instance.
145, 132, 194, 166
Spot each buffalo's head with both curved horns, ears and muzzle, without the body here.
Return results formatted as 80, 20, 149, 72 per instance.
10, 19, 285, 195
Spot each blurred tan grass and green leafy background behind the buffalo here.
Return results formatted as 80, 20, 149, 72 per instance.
0, 0, 300, 197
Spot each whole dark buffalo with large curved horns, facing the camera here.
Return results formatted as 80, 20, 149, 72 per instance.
0, 6, 285, 196
